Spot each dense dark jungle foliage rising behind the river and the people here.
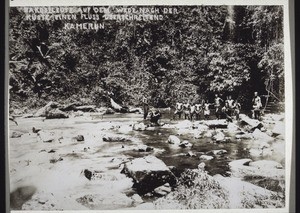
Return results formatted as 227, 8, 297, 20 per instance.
9, 6, 284, 108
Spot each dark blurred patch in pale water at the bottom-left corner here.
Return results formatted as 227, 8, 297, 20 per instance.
10, 186, 36, 210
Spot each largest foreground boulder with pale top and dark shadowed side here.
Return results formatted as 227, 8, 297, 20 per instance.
121, 155, 176, 194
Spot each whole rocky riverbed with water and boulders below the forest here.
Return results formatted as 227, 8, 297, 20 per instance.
9, 107, 285, 210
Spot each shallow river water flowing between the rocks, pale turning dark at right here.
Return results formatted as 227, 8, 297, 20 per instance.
9, 110, 285, 210
